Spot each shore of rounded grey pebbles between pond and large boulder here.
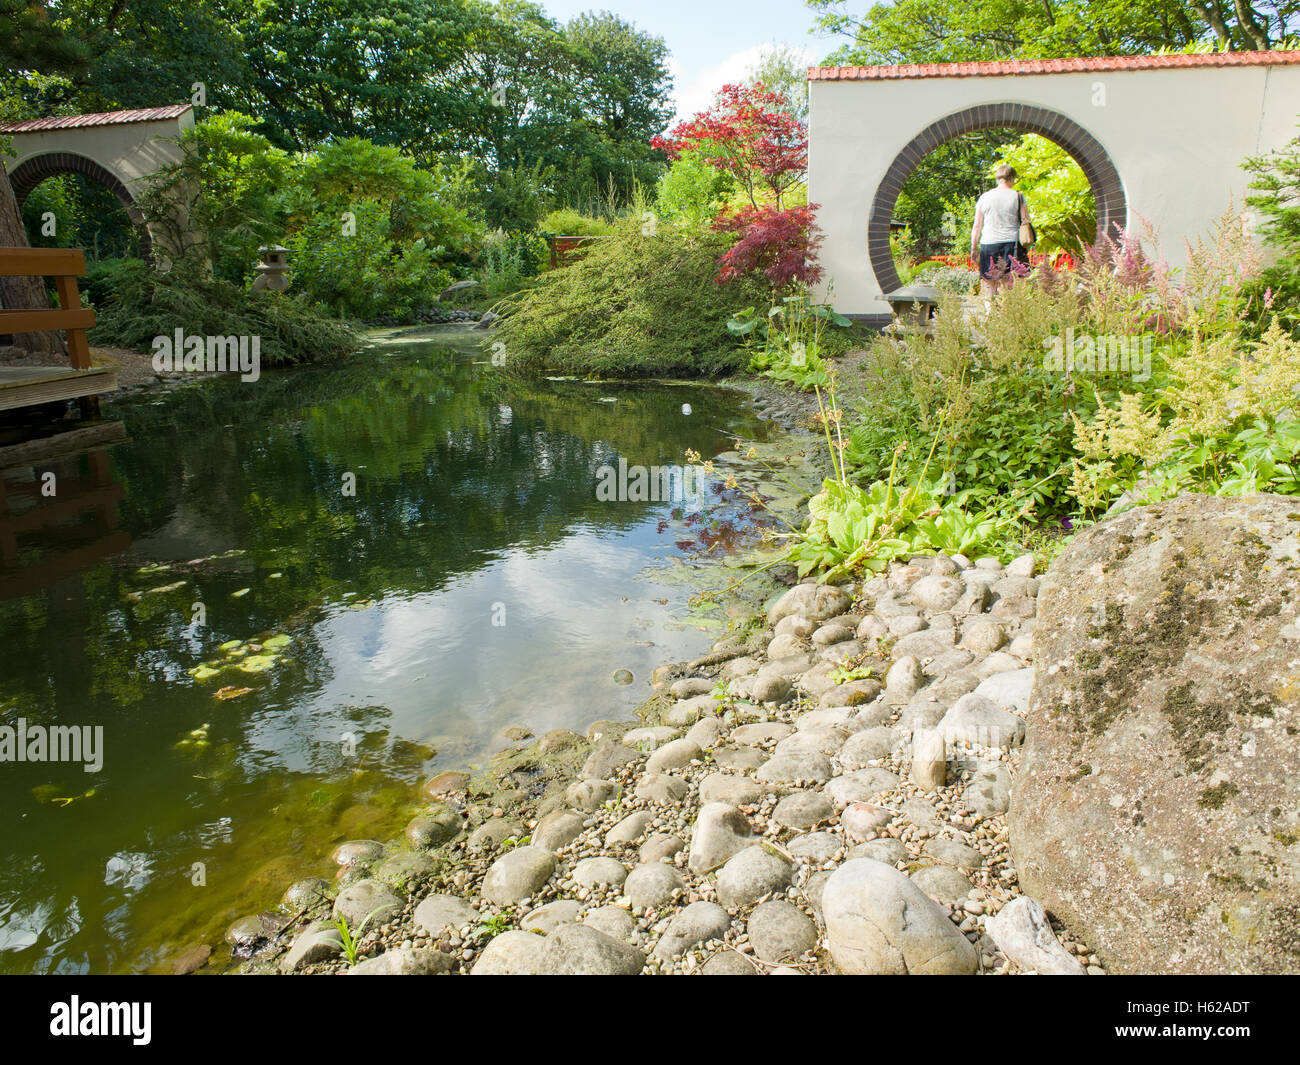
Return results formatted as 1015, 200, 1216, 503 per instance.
210, 380, 1104, 975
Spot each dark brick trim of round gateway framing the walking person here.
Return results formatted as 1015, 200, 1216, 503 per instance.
867, 103, 1128, 293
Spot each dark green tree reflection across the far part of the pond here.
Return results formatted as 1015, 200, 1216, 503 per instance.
106, 345, 758, 605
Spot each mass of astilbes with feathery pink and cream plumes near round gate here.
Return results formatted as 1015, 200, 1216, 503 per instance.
846, 204, 1284, 519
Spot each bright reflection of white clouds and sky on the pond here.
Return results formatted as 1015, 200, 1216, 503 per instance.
259, 528, 699, 765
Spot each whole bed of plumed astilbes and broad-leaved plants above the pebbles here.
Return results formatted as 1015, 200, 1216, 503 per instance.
769, 209, 1300, 587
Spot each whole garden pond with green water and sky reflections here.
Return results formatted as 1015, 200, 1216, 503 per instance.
0, 329, 768, 973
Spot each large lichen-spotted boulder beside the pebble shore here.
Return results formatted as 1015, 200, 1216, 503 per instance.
1009, 495, 1300, 973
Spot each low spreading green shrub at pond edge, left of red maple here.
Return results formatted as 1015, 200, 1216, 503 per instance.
499, 215, 767, 377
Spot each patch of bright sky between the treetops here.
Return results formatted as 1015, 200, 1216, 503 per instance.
530, 0, 842, 118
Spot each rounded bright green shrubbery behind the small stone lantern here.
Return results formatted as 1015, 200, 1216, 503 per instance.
140, 119, 482, 320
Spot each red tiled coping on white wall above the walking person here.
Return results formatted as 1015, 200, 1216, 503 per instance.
809, 52, 1300, 82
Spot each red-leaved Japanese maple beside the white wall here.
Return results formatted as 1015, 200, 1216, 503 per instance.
650, 83, 822, 287
